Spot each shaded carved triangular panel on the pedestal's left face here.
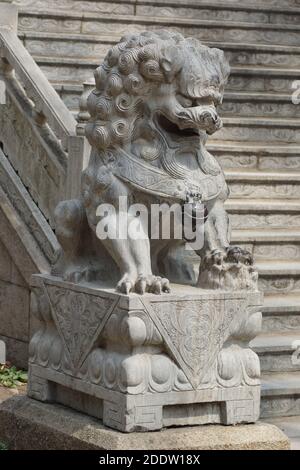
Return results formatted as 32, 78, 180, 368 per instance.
45, 285, 118, 369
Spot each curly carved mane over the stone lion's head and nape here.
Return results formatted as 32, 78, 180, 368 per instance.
85, 31, 229, 150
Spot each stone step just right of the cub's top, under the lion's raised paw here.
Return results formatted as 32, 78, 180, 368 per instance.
231, 228, 300, 262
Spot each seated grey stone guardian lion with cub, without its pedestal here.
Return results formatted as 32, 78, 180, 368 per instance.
53, 31, 257, 294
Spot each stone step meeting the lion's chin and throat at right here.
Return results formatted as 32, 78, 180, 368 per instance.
207, 139, 300, 171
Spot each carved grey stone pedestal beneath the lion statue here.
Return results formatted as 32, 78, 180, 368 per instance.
28, 275, 262, 432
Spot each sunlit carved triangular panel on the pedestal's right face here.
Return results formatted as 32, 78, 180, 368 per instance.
147, 299, 245, 388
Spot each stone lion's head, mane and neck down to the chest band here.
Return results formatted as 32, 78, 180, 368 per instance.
86, 31, 229, 199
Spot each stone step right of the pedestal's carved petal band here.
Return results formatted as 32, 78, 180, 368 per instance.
251, 332, 300, 373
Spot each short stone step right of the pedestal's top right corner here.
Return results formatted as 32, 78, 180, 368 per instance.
262, 295, 300, 334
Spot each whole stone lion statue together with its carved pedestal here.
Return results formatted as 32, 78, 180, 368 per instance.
22, 31, 262, 432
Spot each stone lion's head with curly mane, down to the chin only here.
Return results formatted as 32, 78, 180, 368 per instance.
86, 31, 229, 150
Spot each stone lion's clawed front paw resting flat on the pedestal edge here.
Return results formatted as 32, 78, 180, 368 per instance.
117, 273, 170, 294
